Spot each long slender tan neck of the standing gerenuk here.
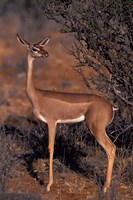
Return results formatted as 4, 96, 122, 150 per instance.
26, 53, 35, 105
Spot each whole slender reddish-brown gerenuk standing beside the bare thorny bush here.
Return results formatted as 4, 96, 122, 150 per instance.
17, 36, 117, 192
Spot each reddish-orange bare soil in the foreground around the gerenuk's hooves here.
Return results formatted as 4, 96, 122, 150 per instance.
7, 160, 133, 200
